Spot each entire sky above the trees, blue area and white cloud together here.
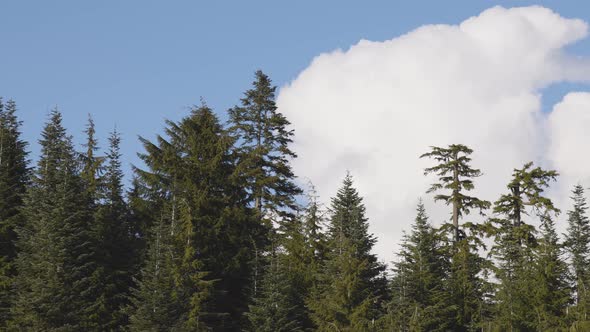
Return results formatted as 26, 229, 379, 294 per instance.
0, 0, 590, 261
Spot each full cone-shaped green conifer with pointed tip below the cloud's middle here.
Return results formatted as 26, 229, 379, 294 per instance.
309, 174, 387, 331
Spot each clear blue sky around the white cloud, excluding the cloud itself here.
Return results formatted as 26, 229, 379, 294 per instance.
0, 0, 590, 183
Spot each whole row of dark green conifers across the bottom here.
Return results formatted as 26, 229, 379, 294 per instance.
0, 71, 590, 332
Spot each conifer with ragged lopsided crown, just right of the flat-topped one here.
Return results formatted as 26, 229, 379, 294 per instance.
489, 163, 559, 330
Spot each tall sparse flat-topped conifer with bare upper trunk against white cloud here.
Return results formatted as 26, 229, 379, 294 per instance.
420, 144, 491, 331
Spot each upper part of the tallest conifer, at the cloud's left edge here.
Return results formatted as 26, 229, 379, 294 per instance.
229, 70, 301, 218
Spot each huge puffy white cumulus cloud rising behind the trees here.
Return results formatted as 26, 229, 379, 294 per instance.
277, 7, 590, 261
